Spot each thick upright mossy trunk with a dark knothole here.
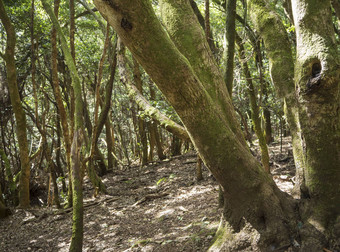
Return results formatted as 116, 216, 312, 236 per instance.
292, 0, 340, 227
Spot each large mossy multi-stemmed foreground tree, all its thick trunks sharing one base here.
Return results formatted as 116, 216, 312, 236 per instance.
94, 0, 340, 251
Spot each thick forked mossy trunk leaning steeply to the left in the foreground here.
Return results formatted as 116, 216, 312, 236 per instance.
95, 0, 295, 249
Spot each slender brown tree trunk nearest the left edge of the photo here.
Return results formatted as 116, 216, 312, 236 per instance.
0, 0, 30, 208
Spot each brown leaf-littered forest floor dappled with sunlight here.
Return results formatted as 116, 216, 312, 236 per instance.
0, 138, 295, 252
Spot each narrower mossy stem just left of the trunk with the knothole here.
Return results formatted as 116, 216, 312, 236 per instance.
248, 0, 305, 195
